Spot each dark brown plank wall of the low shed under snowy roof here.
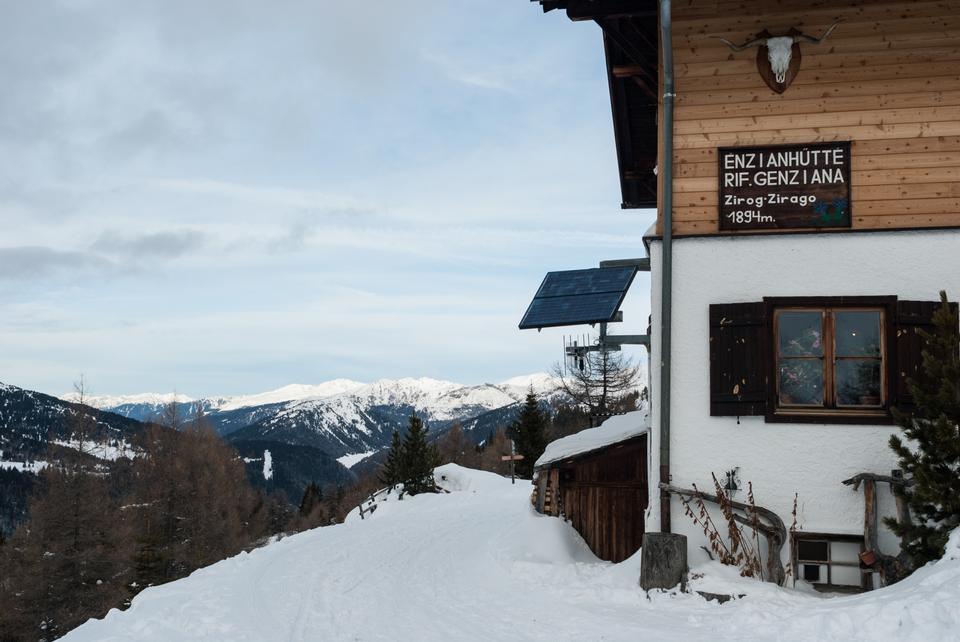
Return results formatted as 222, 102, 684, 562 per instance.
534, 435, 648, 562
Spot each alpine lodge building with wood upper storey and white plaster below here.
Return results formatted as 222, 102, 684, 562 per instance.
521, 0, 960, 590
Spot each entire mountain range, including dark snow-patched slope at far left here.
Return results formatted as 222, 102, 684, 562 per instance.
0, 374, 562, 533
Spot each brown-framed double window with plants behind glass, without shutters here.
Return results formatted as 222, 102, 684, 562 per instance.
773, 307, 886, 413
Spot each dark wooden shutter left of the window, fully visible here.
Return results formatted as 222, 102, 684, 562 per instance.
710, 302, 770, 417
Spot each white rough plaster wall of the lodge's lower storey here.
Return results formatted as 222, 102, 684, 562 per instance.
648, 230, 960, 563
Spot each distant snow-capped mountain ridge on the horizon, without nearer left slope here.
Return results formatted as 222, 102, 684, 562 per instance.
71, 373, 558, 458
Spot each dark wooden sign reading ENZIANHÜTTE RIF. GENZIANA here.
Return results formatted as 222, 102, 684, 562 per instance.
717, 141, 852, 230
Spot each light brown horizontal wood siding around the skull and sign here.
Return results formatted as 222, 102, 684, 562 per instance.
658, 0, 960, 235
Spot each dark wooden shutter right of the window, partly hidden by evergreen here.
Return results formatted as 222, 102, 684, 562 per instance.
888, 301, 957, 413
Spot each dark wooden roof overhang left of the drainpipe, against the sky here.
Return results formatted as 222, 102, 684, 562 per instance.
533, 0, 660, 209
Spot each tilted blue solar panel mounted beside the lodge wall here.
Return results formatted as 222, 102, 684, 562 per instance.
520, 266, 637, 330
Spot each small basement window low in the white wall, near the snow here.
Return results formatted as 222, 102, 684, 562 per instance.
793, 533, 870, 591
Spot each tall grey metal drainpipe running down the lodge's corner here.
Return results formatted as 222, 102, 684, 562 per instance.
660, 0, 674, 533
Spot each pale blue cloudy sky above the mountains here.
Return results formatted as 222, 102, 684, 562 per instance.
0, 0, 654, 397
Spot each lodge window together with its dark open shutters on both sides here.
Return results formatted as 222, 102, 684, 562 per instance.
709, 296, 956, 424
